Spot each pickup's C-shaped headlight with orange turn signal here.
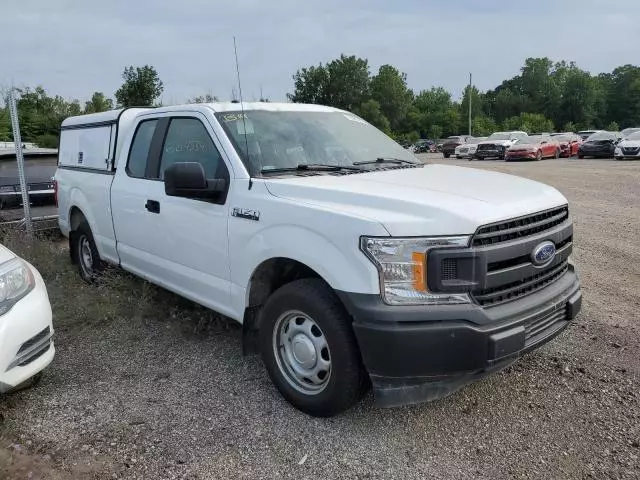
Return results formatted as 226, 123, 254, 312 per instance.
360, 236, 470, 305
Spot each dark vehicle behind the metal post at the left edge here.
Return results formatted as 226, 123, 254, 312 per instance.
0, 147, 58, 208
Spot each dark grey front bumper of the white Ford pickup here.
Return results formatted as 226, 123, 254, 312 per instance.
340, 266, 582, 407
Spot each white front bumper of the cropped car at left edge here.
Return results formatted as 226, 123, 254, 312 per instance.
0, 268, 55, 393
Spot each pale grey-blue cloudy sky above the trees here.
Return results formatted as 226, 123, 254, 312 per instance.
0, 0, 640, 104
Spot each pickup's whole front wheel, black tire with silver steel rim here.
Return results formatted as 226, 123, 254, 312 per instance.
259, 278, 368, 417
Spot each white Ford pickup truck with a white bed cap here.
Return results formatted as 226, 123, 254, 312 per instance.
55, 102, 581, 416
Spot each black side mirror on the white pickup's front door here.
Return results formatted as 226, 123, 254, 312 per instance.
164, 162, 227, 198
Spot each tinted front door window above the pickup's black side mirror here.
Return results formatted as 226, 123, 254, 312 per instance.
160, 118, 223, 178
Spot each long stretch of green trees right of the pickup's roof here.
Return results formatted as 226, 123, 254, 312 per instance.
288, 55, 640, 140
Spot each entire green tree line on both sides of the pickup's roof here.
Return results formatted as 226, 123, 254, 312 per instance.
0, 55, 640, 147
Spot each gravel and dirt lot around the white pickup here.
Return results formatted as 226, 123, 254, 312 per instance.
0, 157, 640, 479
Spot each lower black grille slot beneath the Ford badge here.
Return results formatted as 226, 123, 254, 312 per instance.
473, 260, 569, 307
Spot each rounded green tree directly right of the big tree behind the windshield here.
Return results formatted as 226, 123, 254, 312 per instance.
370, 65, 413, 131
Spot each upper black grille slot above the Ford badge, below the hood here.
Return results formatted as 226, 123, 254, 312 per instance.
472, 205, 569, 247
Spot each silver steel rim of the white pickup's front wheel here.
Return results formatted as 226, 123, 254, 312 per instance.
272, 310, 331, 395
